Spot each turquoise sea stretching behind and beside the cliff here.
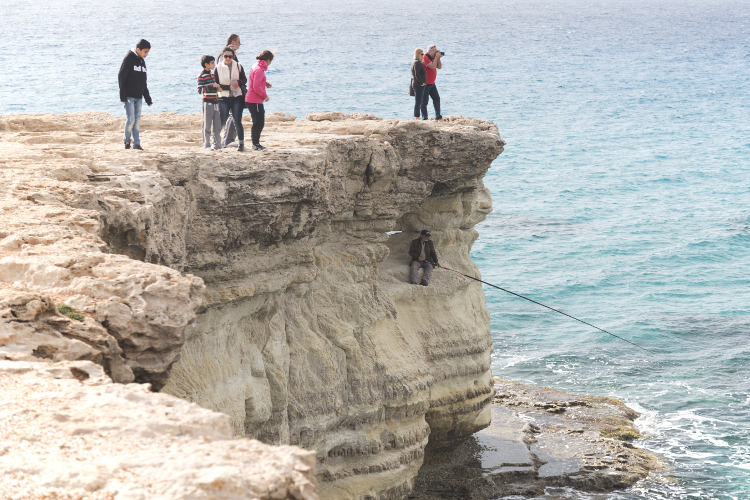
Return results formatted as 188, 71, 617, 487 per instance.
0, 0, 750, 499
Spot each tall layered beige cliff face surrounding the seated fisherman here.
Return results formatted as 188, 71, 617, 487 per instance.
151, 114, 502, 498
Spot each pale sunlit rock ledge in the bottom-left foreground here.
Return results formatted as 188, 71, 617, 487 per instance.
0, 361, 318, 500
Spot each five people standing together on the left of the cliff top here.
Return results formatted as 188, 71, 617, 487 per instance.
118, 33, 273, 151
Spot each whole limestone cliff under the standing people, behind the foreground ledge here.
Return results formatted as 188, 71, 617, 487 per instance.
0, 113, 503, 498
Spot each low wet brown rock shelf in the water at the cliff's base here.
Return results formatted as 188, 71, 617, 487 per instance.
409, 378, 665, 500
